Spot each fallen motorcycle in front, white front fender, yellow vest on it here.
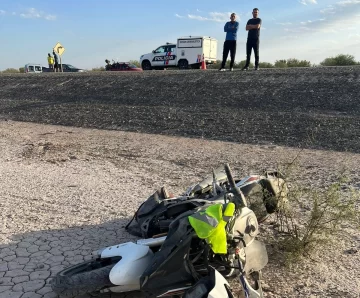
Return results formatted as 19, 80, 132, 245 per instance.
52, 164, 268, 298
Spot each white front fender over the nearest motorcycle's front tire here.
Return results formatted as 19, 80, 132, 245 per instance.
101, 242, 154, 292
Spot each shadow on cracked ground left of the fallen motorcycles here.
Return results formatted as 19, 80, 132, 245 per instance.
0, 219, 149, 298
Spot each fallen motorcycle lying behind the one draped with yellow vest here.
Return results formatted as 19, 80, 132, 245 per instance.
125, 167, 288, 238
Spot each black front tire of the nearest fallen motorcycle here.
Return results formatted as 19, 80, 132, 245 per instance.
51, 260, 116, 297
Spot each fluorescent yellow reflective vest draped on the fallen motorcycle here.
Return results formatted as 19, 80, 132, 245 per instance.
188, 203, 235, 254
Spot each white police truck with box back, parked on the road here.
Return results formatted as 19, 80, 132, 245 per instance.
140, 36, 217, 70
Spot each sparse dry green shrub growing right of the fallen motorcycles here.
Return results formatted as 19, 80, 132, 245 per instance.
274, 157, 360, 266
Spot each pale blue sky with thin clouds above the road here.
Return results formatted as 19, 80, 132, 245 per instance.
0, 0, 360, 70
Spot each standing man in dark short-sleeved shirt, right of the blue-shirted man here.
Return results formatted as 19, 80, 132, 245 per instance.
242, 8, 261, 70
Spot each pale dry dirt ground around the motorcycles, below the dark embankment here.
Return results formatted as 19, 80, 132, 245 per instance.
0, 120, 360, 298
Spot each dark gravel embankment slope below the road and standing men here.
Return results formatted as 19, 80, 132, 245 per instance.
0, 67, 360, 153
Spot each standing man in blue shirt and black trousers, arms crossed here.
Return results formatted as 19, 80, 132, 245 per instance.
219, 13, 239, 71
